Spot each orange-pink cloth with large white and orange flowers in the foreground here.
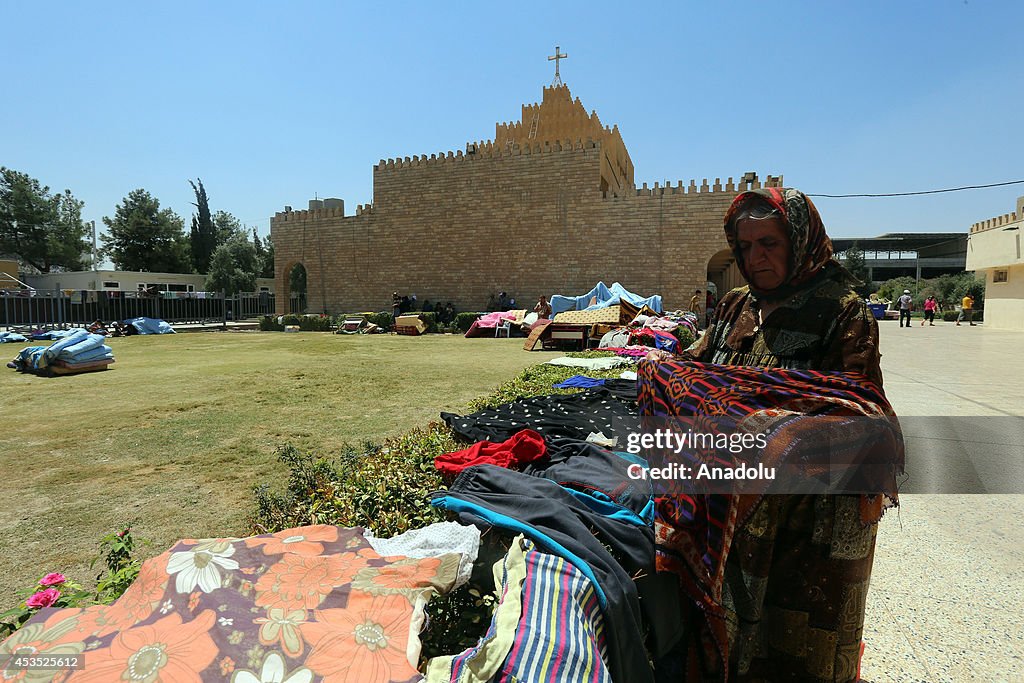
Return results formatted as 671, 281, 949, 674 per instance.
0, 525, 459, 683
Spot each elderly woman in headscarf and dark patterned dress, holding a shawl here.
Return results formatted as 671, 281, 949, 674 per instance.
648, 188, 895, 681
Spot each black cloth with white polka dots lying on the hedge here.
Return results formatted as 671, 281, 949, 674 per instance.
441, 382, 640, 444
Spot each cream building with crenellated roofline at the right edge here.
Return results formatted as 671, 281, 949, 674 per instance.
967, 197, 1024, 330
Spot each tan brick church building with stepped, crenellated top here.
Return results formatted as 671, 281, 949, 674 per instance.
270, 82, 781, 313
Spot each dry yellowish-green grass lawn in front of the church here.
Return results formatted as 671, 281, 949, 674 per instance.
0, 333, 555, 611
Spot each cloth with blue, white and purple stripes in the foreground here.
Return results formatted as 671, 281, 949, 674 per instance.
496, 542, 611, 683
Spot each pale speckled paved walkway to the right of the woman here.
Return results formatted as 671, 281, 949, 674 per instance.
861, 322, 1024, 683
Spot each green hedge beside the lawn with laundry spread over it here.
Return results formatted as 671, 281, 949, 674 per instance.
251, 358, 621, 657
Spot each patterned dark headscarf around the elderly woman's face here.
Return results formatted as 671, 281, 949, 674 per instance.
725, 187, 838, 301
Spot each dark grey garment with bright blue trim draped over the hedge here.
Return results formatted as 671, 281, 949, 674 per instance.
431, 465, 654, 683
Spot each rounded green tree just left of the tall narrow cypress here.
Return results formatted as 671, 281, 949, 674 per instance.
101, 189, 191, 272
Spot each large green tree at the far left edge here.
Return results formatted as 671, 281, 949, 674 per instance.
0, 168, 89, 272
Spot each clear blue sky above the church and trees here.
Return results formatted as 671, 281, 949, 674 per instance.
0, 0, 1024, 259
